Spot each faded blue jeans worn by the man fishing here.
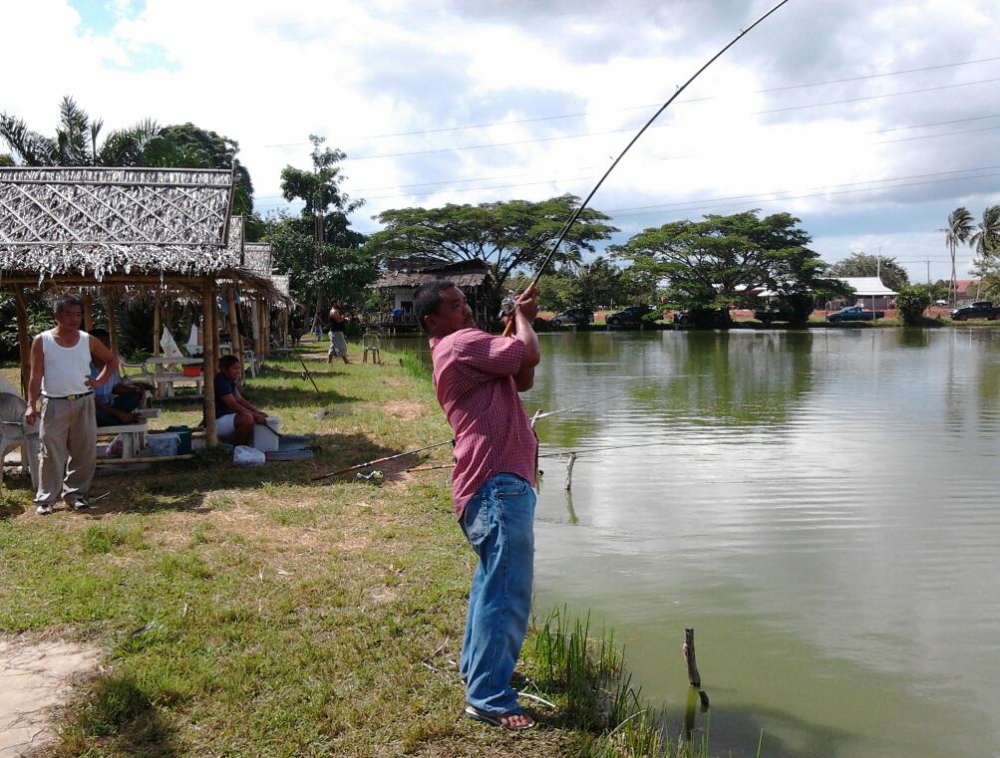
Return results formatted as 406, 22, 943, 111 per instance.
458, 474, 535, 713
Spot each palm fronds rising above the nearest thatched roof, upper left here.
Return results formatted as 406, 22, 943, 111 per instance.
0, 96, 160, 166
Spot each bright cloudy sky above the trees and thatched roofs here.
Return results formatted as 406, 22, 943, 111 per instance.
0, 0, 1000, 282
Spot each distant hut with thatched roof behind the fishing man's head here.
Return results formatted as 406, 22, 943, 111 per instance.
365, 256, 495, 328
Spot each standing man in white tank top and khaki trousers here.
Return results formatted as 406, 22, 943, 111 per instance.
24, 297, 118, 516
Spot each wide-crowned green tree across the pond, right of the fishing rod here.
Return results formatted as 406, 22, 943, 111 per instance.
610, 210, 838, 323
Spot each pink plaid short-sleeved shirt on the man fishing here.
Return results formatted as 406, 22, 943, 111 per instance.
430, 328, 538, 518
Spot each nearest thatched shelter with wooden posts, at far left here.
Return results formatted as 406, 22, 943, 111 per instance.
0, 167, 264, 443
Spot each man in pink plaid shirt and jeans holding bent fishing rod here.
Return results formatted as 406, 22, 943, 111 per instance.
414, 281, 541, 729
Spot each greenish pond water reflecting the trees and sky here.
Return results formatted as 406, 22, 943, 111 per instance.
390, 328, 1000, 758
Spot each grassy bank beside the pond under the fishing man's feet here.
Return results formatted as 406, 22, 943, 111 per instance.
0, 344, 696, 758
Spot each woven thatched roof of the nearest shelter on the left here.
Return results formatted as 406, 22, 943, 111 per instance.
0, 167, 241, 280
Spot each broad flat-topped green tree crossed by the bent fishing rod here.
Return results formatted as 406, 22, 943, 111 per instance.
371, 195, 618, 312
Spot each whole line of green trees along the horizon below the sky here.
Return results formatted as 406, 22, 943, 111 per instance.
0, 97, 1000, 339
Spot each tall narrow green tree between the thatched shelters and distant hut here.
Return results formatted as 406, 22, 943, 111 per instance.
274, 134, 368, 317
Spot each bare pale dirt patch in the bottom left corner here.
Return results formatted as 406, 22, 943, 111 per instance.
0, 639, 101, 758
